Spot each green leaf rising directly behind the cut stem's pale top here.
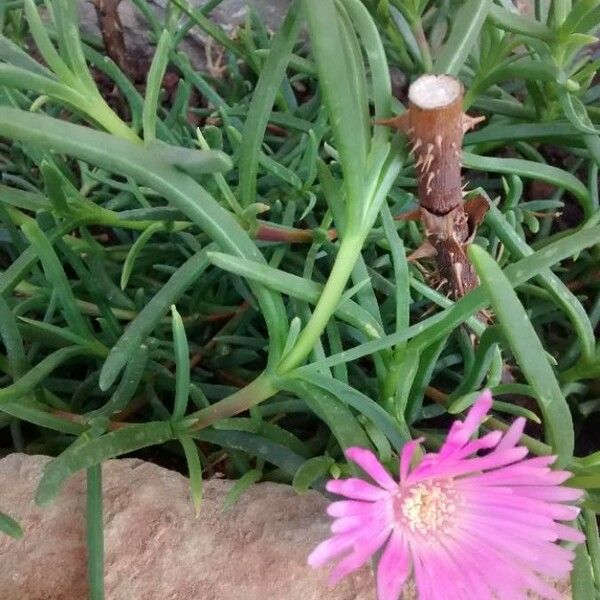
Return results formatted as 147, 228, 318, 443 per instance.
433, 0, 492, 76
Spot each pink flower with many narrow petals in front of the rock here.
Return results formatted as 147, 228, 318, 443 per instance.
308, 391, 584, 600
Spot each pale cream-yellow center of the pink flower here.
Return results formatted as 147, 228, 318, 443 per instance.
395, 480, 459, 535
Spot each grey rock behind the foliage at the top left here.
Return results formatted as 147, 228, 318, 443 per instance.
79, 0, 290, 69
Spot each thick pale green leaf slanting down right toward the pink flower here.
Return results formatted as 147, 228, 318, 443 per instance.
469, 245, 574, 465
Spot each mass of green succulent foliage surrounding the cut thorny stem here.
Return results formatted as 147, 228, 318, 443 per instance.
0, 0, 600, 600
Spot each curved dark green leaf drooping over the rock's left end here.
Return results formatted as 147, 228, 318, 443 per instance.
35, 421, 174, 505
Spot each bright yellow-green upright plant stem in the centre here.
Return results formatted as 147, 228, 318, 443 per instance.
277, 235, 365, 375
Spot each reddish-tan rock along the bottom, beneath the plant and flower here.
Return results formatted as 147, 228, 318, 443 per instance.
0, 454, 571, 600
